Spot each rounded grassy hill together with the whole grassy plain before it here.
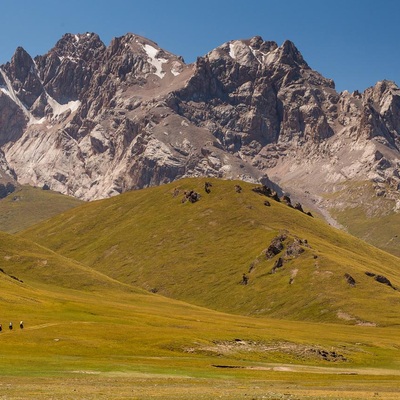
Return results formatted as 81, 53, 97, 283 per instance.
0, 179, 400, 400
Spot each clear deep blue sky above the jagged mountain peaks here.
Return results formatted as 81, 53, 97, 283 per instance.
0, 0, 400, 91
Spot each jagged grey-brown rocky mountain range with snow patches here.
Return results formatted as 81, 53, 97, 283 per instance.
0, 33, 400, 220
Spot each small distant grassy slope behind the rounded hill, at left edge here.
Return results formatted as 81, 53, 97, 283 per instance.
0, 186, 83, 233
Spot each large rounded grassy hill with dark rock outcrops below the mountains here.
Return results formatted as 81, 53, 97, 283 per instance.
23, 179, 400, 325
